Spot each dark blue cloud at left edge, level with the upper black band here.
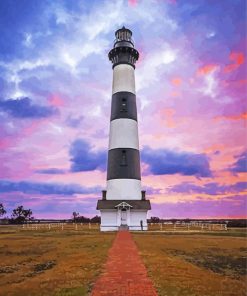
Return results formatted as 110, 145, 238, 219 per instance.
0, 97, 57, 118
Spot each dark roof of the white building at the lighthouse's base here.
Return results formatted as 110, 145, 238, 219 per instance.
97, 200, 151, 210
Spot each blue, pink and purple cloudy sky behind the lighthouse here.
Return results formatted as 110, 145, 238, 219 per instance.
0, 0, 247, 219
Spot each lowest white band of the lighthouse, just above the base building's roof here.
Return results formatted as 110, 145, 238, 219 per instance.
106, 179, 142, 200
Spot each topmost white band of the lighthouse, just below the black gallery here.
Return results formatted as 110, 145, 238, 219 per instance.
112, 64, 135, 94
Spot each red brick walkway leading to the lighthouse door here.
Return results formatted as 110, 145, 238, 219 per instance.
91, 231, 157, 296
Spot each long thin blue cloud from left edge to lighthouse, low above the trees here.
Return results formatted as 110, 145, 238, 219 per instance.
0, 180, 101, 195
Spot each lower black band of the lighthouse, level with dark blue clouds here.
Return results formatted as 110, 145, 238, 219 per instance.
107, 148, 141, 180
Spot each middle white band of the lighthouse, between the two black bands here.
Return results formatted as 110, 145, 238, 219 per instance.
109, 118, 139, 150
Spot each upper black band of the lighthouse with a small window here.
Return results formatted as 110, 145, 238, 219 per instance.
111, 91, 137, 121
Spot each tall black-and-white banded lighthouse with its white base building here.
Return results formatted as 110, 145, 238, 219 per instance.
97, 27, 151, 231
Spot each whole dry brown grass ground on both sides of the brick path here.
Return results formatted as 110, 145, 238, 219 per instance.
0, 224, 247, 296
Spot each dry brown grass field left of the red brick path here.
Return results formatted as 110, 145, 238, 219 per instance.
0, 226, 115, 296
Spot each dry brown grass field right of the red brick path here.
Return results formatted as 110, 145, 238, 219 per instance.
133, 231, 247, 296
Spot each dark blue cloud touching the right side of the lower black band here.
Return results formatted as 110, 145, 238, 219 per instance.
141, 146, 211, 177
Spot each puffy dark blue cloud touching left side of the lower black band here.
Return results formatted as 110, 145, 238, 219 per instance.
69, 139, 106, 172
